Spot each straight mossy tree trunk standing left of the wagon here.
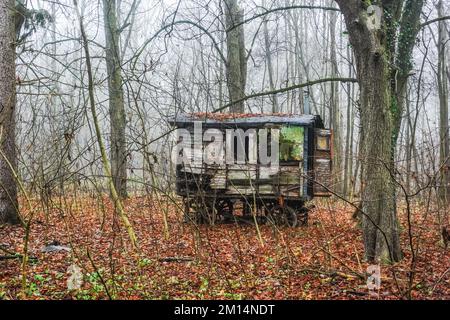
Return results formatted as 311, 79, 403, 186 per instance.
103, 0, 127, 198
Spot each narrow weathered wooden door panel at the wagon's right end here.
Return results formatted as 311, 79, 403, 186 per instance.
313, 129, 331, 197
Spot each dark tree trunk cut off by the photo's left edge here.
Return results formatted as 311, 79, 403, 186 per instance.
0, 0, 21, 224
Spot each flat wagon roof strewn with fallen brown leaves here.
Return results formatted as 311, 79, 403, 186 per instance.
169, 112, 323, 128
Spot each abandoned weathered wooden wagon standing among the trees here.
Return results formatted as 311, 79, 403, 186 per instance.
170, 113, 332, 227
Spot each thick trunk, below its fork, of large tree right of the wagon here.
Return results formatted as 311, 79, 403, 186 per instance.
356, 51, 401, 262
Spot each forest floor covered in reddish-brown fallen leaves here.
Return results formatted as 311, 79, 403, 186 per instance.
0, 197, 450, 299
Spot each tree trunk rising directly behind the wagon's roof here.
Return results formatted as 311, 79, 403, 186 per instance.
224, 0, 247, 113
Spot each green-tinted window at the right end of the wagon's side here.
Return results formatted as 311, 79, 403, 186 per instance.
280, 126, 304, 162
